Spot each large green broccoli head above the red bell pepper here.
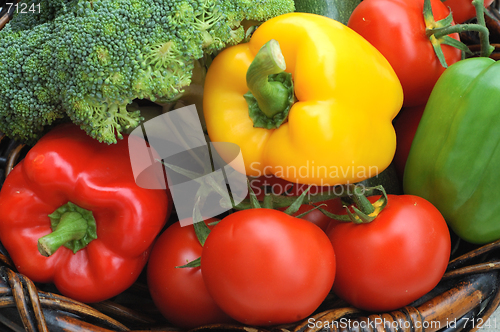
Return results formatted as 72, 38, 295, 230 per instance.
0, 0, 294, 144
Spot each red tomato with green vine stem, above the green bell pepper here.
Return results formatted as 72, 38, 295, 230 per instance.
347, 0, 461, 106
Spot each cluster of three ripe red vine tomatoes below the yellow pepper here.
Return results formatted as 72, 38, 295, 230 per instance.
148, 181, 451, 328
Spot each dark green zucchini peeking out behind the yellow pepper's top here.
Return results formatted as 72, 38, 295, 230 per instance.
295, 0, 361, 25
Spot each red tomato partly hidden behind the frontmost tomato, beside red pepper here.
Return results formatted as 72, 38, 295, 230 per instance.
147, 219, 234, 329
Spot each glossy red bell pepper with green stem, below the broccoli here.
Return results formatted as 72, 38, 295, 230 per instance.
0, 124, 172, 302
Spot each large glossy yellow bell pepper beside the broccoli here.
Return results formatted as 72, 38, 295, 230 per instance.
203, 13, 403, 186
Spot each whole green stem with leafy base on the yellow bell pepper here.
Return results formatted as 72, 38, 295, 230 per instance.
245, 39, 294, 129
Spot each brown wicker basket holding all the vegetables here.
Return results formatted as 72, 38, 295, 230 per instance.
0, 1, 500, 332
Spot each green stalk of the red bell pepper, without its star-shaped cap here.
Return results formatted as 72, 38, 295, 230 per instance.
38, 212, 88, 257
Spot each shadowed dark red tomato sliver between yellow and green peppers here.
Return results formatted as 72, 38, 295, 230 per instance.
394, 104, 425, 183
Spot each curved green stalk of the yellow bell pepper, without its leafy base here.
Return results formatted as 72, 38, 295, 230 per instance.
246, 39, 290, 119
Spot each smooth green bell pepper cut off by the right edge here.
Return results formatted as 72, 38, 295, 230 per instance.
403, 57, 500, 244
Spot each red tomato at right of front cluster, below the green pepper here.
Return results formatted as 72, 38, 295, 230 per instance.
329, 195, 451, 312
